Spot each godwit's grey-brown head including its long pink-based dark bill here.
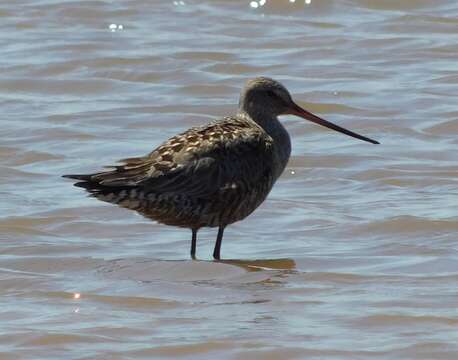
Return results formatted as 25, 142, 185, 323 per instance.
239, 77, 379, 144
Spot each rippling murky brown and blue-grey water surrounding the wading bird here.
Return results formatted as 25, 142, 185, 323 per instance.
0, 0, 458, 360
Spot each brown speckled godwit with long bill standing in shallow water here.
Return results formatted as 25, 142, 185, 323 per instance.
64, 77, 378, 260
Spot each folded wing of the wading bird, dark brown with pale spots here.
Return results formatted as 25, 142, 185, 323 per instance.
66, 118, 273, 196
